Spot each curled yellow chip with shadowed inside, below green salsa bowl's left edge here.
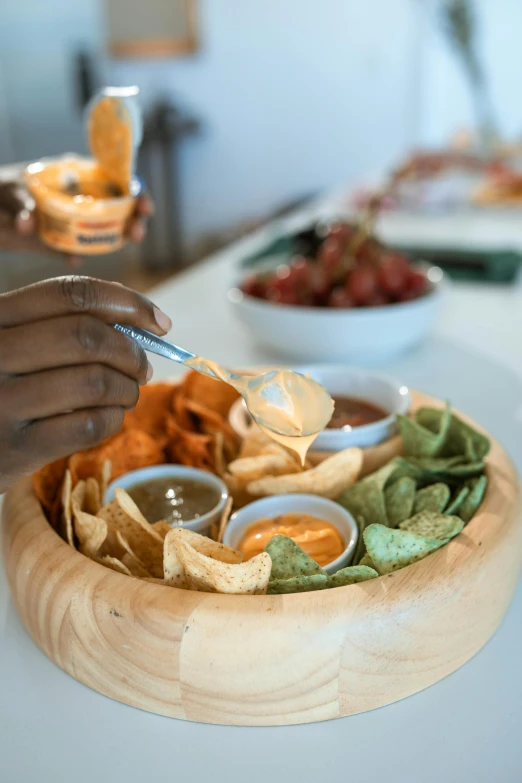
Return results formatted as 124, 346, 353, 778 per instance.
100, 489, 163, 579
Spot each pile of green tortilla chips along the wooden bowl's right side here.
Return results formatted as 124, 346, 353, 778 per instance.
338, 405, 490, 574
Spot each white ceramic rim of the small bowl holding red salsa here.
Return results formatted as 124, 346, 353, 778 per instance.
229, 364, 410, 451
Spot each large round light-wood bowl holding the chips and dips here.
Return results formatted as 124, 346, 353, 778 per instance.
3, 395, 522, 726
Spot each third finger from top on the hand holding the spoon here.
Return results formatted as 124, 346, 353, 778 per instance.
2, 364, 139, 424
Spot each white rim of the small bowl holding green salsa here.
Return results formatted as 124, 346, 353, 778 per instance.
104, 465, 228, 535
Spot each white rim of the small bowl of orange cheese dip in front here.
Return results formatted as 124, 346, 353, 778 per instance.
223, 495, 359, 574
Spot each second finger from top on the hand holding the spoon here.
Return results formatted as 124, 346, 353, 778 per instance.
0, 315, 151, 384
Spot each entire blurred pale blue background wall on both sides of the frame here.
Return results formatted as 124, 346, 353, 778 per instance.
0, 0, 522, 280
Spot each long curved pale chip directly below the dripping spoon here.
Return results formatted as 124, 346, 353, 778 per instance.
247, 448, 363, 500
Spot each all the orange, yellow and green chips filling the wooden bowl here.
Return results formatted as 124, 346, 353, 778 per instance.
34, 373, 490, 594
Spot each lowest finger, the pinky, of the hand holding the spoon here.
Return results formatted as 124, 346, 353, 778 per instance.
19, 406, 125, 472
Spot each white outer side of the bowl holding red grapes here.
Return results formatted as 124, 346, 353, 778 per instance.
228, 267, 445, 365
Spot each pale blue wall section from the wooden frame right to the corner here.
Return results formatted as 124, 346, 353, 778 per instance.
110, 0, 417, 242
